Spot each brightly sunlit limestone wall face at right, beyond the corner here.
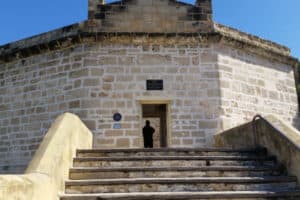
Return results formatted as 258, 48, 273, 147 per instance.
216, 44, 298, 130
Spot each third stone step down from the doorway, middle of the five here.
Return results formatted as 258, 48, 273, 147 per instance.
69, 166, 281, 180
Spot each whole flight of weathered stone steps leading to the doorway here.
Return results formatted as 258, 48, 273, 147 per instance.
61, 148, 300, 200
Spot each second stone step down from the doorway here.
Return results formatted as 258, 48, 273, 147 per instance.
74, 156, 276, 167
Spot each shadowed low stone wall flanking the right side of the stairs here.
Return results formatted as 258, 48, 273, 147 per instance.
215, 115, 300, 185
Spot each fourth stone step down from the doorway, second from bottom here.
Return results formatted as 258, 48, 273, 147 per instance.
65, 176, 297, 194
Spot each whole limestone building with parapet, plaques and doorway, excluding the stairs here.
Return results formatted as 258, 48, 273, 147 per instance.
0, 0, 298, 172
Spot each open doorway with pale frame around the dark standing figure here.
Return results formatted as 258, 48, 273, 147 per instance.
142, 104, 168, 148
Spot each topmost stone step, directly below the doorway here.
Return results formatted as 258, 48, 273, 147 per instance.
77, 148, 267, 157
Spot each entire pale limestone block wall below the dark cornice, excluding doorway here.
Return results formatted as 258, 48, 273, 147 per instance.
0, 36, 297, 172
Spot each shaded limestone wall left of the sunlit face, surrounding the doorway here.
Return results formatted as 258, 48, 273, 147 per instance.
0, 43, 219, 172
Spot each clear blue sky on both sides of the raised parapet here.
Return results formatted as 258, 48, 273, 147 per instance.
0, 0, 300, 59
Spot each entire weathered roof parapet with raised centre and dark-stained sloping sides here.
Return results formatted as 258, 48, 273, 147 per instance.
0, 0, 298, 65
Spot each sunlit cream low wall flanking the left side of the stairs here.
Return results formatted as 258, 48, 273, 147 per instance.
0, 113, 92, 200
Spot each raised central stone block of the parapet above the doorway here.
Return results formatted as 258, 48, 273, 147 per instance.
88, 0, 213, 33
